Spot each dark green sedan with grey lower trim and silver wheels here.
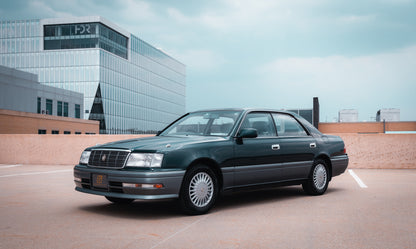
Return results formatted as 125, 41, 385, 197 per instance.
74, 109, 348, 214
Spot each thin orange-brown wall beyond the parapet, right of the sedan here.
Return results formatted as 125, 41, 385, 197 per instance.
319, 122, 416, 133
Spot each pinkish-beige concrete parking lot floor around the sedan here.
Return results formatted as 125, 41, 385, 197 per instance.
0, 165, 416, 248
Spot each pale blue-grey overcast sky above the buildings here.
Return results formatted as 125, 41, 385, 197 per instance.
0, 0, 416, 122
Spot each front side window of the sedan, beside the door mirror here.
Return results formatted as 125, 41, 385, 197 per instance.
241, 112, 276, 137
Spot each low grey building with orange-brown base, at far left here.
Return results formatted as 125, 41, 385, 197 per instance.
0, 66, 99, 134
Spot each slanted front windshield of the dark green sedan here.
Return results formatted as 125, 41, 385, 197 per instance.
160, 110, 241, 137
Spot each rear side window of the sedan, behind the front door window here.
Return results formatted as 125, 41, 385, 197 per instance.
273, 113, 308, 137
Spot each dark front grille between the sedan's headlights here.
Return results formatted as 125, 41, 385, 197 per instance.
88, 150, 130, 169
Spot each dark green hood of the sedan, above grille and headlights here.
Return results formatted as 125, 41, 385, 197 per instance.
89, 136, 226, 152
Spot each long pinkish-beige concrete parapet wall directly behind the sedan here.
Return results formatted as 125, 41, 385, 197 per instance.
0, 133, 416, 169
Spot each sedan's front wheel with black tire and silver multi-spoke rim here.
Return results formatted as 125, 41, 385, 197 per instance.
179, 165, 218, 215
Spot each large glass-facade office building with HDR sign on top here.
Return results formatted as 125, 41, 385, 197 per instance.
0, 17, 186, 134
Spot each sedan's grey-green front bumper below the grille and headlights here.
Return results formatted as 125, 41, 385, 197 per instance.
74, 165, 185, 200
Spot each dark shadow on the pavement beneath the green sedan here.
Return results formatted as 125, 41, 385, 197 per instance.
79, 186, 343, 220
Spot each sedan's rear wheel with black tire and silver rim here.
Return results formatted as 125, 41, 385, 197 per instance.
302, 159, 329, 195
